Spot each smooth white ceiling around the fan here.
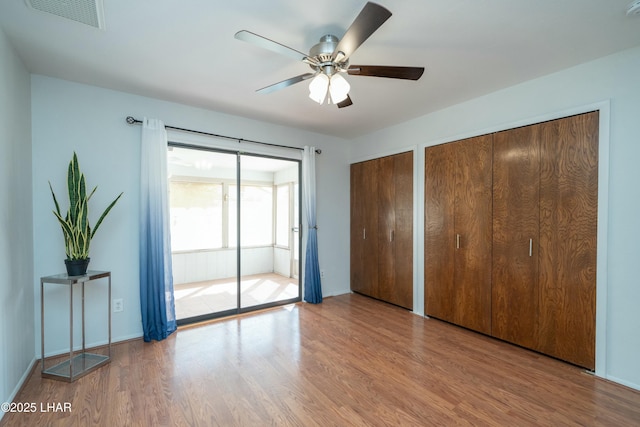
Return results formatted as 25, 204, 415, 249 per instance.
0, 0, 640, 138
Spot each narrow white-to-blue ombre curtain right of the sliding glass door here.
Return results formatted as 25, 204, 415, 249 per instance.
302, 146, 322, 304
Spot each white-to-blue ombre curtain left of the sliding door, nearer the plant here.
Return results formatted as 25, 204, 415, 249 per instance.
140, 117, 177, 342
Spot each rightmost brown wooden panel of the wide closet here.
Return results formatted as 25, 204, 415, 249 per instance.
537, 112, 599, 369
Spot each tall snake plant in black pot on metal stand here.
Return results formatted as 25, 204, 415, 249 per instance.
49, 152, 122, 276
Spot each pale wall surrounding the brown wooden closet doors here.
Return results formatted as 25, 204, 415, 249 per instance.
351, 48, 640, 389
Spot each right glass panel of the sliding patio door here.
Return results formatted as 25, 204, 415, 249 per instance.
239, 155, 300, 310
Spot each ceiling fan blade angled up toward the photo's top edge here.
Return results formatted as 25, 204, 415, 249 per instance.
332, 2, 391, 61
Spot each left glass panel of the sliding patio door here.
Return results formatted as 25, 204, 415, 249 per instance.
167, 147, 238, 323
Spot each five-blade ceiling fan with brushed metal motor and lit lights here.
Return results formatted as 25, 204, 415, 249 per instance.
235, 2, 424, 108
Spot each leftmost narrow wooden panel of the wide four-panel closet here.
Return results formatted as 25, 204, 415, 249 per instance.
424, 143, 456, 322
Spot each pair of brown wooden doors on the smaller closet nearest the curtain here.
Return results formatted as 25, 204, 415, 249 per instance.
351, 151, 413, 309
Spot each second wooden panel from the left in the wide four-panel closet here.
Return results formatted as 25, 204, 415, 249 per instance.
454, 135, 493, 334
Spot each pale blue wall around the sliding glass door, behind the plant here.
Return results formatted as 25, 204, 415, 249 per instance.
31, 75, 349, 354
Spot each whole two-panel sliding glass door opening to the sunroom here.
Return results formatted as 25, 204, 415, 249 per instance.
168, 145, 300, 324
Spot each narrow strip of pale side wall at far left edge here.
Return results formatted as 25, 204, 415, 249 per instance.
0, 25, 35, 418
